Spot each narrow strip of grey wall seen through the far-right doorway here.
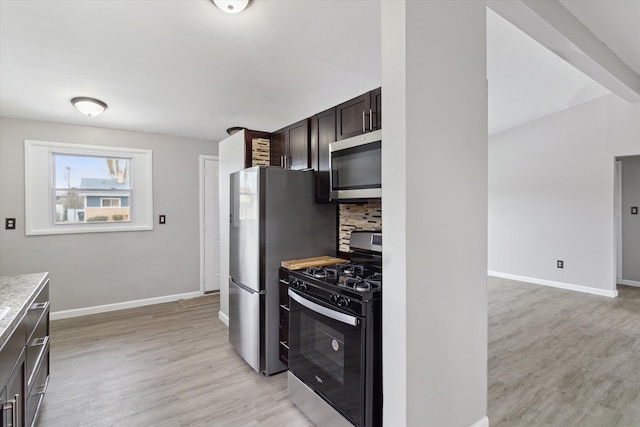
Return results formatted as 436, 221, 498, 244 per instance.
620, 155, 640, 286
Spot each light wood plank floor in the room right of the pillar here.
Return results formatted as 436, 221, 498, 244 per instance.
488, 278, 640, 427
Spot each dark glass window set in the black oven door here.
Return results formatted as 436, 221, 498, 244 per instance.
300, 315, 344, 384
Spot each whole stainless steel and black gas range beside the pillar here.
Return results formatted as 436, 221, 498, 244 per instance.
288, 231, 382, 427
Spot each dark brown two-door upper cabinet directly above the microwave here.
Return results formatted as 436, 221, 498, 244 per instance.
336, 88, 382, 140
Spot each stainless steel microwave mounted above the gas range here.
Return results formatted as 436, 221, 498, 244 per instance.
329, 129, 382, 200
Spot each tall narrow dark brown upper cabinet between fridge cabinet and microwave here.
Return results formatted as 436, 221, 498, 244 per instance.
310, 107, 336, 203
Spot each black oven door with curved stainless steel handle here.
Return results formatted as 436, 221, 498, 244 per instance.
289, 289, 365, 426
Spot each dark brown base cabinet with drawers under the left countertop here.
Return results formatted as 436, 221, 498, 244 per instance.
0, 281, 49, 427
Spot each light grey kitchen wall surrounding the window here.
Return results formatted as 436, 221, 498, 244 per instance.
0, 118, 218, 312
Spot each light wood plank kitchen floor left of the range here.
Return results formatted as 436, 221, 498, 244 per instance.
38, 296, 311, 427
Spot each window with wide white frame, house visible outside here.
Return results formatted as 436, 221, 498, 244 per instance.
25, 141, 153, 235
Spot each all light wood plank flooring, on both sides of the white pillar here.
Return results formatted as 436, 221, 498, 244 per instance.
38, 278, 640, 427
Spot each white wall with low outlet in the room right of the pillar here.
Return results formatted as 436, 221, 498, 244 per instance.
489, 95, 640, 296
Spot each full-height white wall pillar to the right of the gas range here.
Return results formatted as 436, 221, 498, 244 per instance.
381, 0, 487, 427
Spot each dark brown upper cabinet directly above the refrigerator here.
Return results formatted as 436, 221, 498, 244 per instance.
271, 119, 310, 169
